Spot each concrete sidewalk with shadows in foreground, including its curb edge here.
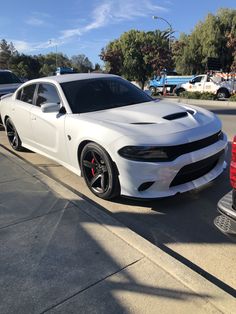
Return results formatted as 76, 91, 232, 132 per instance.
0, 147, 236, 314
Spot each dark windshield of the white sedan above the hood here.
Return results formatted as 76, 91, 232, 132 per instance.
61, 77, 152, 113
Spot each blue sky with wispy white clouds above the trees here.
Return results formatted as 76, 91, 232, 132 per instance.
0, 0, 236, 64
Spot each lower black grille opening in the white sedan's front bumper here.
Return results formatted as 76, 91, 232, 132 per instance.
170, 150, 224, 187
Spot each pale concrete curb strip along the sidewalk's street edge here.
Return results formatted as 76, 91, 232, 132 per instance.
2, 147, 236, 313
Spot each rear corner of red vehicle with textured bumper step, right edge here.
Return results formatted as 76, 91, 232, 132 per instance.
214, 136, 236, 235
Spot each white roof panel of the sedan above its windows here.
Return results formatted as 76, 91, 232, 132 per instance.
27, 73, 118, 83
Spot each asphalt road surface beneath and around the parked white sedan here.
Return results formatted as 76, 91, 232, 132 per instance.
0, 105, 236, 294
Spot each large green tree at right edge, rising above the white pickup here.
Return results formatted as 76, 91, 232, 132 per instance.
173, 9, 236, 74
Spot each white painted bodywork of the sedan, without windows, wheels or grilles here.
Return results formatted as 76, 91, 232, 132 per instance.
0, 74, 227, 198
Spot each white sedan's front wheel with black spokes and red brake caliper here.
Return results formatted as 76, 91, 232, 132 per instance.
80, 143, 120, 200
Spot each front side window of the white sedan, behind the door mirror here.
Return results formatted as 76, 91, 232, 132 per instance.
36, 84, 61, 107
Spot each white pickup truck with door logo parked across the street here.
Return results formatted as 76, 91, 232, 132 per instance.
174, 74, 236, 98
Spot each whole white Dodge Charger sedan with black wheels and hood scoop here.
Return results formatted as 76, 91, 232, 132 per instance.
0, 74, 227, 199
